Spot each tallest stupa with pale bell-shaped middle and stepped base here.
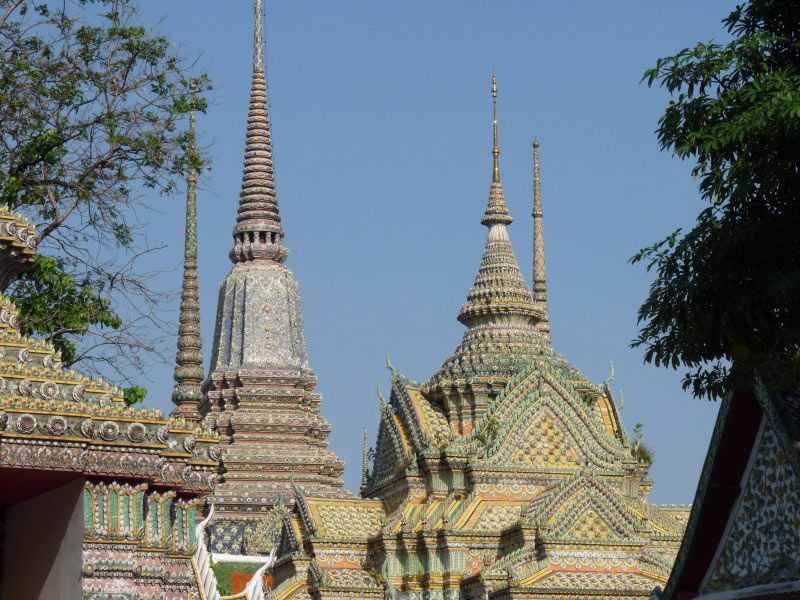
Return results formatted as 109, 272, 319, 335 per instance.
202, 0, 346, 552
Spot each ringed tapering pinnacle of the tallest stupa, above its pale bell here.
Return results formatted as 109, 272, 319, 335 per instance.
231, 0, 289, 263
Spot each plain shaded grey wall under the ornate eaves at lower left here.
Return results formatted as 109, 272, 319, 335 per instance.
0, 479, 84, 600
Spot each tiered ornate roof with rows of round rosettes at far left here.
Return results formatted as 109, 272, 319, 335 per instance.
0, 204, 219, 492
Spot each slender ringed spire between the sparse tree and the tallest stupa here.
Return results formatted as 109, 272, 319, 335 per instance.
172, 84, 204, 421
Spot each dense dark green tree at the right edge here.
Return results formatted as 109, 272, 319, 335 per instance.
631, 0, 800, 399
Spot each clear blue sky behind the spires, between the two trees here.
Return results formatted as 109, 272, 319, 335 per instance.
133, 0, 734, 503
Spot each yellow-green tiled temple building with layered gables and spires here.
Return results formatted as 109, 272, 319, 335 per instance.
262, 77, 688, 600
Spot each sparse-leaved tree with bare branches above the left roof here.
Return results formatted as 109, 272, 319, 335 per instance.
0, 0, 210, 382
